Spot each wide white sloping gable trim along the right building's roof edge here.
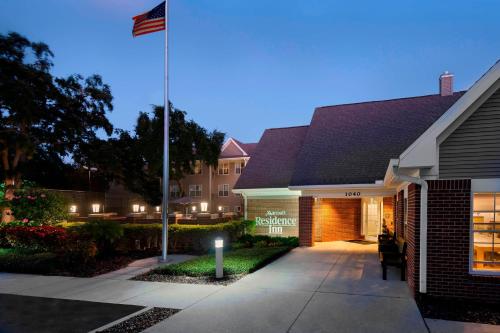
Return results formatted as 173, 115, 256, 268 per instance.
399, 61, 500, 168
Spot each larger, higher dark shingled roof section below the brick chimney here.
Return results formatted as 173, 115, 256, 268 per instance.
290, 92, 464, 186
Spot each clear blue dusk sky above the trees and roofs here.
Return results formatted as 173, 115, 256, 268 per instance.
0, 0, 500, 142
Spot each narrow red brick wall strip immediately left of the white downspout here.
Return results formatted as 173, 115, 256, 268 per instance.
405, 184, 420, 295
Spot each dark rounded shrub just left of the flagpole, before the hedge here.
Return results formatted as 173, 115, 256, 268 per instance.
79, 220, 123, 254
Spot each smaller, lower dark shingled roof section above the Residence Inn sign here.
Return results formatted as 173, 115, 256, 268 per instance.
234, 126, 308, 189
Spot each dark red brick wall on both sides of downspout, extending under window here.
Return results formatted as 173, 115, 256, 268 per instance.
407, 179, 500, 302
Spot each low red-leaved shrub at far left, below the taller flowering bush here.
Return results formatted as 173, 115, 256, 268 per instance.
3, 226, 68, 252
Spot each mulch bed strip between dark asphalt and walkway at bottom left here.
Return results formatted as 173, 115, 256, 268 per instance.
98, 308, 180, 333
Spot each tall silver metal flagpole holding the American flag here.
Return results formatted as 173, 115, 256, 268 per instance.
161, 0, 170, 262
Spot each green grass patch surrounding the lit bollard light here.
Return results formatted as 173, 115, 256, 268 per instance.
152, 247, 290, 277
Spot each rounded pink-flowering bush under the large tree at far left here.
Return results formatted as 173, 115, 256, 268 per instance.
8, 188, 68, 225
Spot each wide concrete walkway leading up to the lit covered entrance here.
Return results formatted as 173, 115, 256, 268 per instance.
147, 242, 428, 333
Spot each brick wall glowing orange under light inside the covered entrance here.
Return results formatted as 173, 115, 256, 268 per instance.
315, 199, 362, 242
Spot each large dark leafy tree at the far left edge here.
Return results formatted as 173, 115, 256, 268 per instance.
0, 32, 113, 220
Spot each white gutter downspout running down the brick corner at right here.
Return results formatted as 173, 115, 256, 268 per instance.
392, 165, 429, 294
